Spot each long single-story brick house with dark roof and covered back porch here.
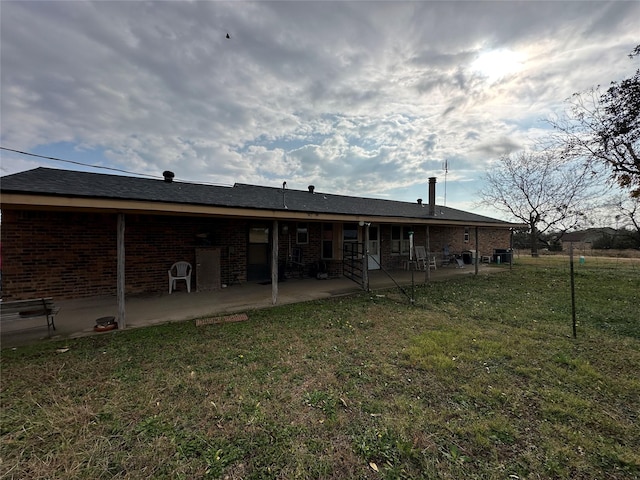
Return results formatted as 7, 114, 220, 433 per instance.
1, 168, 519, 299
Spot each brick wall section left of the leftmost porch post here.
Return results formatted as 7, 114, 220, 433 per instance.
2, 209, 116, 300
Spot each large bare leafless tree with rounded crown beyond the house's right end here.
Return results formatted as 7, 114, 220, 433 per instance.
480, 150, 599, 256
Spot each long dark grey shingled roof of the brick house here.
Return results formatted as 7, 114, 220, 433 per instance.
0, 167, 512, 227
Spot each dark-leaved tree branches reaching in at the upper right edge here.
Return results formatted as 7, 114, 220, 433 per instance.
550, 45, 640, 198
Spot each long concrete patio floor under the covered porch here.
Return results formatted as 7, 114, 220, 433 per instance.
0, 265, 496, 348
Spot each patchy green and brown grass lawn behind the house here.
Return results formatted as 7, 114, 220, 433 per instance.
0, 259, 640, 479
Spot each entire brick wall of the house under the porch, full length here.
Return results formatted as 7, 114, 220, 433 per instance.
1, 209, 509, 300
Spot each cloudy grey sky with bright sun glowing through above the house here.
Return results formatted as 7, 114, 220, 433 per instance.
0, 0, 640, 218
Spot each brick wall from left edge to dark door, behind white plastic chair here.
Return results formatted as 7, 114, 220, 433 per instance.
1, 209, 247, 299
